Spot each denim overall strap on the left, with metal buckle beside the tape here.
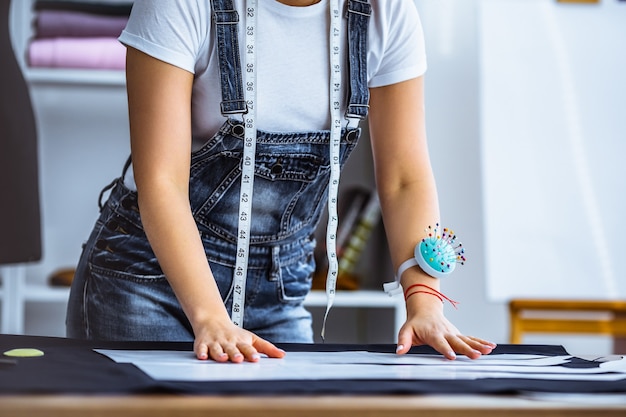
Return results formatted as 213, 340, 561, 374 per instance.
211, 0, 248, 116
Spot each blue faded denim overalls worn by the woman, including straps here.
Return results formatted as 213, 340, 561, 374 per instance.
67, 0, 370, 343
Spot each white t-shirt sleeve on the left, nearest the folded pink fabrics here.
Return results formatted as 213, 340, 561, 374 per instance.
114, 0, 210, 73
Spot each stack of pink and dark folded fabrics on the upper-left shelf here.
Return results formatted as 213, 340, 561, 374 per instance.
28, 0, 132, 70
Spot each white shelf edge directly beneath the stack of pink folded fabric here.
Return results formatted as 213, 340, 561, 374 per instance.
25, 68, 126, 87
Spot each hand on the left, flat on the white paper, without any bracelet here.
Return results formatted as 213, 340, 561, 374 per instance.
193, 320, 285, 363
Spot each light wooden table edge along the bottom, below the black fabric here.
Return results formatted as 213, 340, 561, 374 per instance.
0, 394, 626, 417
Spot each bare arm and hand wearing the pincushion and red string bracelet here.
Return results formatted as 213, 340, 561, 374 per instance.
369, 77, 495, 359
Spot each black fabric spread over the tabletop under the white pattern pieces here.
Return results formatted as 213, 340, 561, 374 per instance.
0, 335, 626, 395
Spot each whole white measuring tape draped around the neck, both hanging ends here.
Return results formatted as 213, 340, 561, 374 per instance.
231, 0, 342, 339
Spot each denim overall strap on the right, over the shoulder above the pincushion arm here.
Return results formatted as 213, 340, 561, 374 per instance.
346, 0, 372, 120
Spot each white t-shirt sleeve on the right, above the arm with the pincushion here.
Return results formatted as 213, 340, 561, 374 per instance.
369, 0, 427, 87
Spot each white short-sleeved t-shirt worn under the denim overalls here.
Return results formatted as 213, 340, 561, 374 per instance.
119, 0, 426, 149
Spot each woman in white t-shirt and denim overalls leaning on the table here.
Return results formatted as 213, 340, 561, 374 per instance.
68, 0, 494, 362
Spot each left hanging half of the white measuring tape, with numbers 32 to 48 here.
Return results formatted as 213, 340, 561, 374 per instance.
231, 0, 257, 327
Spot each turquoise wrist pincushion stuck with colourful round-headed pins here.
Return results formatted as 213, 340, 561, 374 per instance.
415, 223, 465, 278
